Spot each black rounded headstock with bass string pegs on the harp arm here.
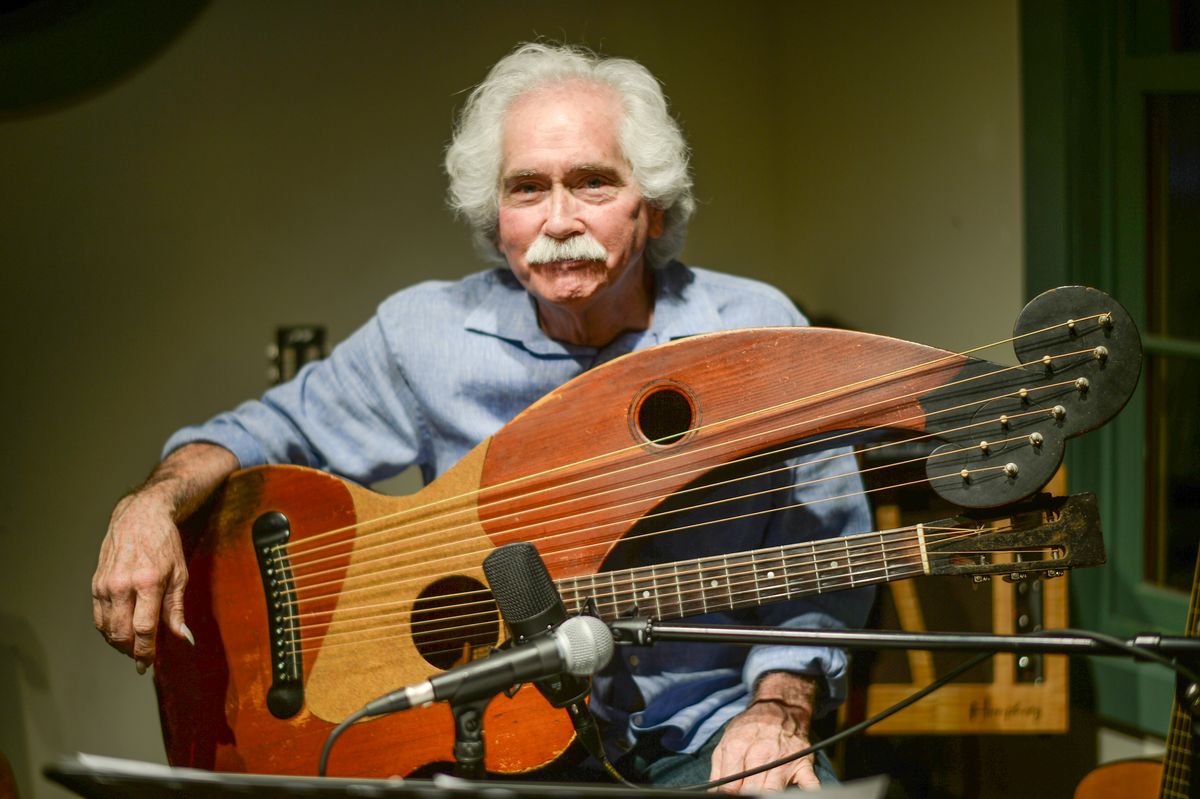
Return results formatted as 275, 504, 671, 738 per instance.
922, 286, 1141, 507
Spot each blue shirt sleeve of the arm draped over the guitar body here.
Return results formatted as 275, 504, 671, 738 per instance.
163, 314, 427, 485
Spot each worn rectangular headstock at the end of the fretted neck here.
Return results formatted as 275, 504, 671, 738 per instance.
923, 493, 1106, 581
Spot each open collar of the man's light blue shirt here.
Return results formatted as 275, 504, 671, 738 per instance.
463, 260, 724, 358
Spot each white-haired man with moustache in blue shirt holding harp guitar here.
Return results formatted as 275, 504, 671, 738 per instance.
92, 44, 870, 791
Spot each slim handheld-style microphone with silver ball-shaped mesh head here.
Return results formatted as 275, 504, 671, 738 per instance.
361, 615, 612, 716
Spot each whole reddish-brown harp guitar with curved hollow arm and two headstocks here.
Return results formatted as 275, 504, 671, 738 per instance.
155, 287, 1141, 776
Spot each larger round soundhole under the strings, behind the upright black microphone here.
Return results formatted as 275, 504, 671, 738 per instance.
413, 575, 500, 669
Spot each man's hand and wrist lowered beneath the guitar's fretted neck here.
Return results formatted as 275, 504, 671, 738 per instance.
709, 672, 821, 793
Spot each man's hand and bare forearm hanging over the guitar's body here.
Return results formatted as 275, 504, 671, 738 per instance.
91, 444, 238, 674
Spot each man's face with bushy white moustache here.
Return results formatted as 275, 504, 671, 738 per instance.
498, 84, 662, 312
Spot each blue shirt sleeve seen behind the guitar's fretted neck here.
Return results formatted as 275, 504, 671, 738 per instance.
742, 441, 875, 716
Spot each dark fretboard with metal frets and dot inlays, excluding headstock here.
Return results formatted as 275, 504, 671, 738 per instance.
557, 525, 925, 621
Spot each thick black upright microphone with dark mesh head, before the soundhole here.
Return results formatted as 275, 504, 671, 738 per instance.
484, 541, 612, 763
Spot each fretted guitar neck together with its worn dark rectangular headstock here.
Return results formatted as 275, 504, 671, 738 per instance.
557, 494, 1104, 621
